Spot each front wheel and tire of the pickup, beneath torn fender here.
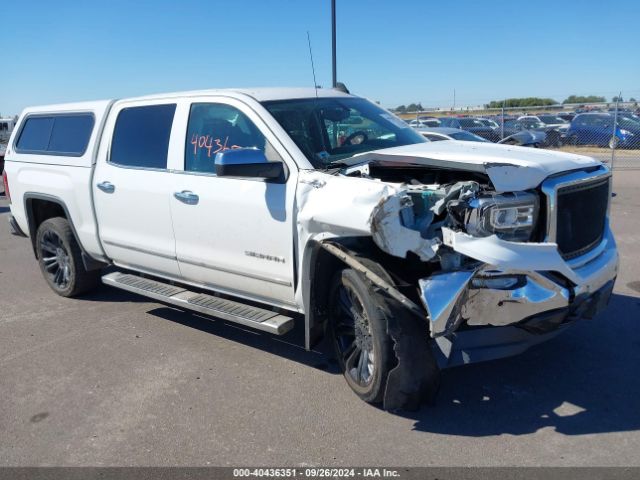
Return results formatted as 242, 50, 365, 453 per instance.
329, 269, 395, 404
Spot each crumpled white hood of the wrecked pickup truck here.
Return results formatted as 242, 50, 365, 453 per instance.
353, 140, 602, 192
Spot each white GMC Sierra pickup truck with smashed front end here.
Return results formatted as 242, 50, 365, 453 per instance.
4, 89, 618, 409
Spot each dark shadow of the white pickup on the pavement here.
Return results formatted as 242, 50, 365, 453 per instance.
136, 286, 640, 437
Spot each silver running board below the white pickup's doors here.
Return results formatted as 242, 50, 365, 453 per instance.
102, 272, 293, 335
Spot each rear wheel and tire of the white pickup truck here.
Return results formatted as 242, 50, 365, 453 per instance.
36, 217, 100, 297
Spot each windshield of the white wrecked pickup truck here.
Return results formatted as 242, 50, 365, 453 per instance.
263, 97, 427, 169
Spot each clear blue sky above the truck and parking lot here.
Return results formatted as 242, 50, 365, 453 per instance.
0, 0, 640, 114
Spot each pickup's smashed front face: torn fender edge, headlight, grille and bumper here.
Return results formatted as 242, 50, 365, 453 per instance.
358, 161, 618, 365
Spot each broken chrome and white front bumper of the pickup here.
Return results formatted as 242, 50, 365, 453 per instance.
419, 226, 618, 364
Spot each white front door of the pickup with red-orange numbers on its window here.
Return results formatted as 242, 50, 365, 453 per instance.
170, 97, 296, 307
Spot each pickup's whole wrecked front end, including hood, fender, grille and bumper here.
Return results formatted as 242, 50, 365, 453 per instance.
297, 142, 618, 409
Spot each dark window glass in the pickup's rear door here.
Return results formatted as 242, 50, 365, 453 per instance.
110, 103, 176, 169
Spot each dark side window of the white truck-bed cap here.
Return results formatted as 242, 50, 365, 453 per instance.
16, 113, 94, 156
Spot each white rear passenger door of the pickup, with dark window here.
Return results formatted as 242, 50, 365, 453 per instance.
92, 101, 180, 277
